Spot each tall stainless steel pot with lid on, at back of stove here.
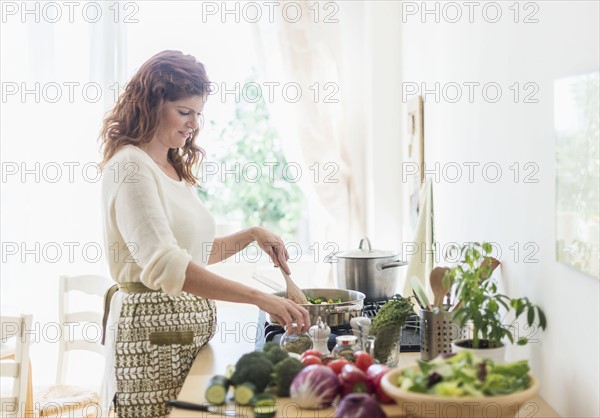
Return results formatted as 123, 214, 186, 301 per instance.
326, 237, 407, 302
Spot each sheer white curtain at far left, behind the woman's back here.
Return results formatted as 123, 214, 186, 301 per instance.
0, 2, 125, 384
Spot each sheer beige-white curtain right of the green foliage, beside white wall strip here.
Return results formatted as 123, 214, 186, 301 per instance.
255, 1, 368, 268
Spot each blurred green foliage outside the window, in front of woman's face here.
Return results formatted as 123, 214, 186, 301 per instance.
199, 73, 306, 241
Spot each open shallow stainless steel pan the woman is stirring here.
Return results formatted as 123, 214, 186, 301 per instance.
267, 289, 365, 327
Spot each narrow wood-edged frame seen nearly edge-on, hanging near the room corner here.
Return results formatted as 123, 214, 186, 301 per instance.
406, 96, 425, 228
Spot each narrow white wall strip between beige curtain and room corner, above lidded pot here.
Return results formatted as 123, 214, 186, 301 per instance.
364, 1, 404, 251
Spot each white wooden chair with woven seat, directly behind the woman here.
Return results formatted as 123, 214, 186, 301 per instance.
34, 275, 112, 417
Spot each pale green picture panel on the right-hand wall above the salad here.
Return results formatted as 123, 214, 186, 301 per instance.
554, 71, 600, 278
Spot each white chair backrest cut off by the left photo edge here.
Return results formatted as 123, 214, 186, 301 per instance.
0, 315, 33, 417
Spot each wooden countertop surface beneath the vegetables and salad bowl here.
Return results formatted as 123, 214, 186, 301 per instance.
170, 302, 559, 418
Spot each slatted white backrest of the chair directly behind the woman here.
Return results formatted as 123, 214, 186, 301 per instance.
56, 275, 113, 384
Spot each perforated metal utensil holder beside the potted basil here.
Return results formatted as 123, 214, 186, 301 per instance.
419, 309, 463, 361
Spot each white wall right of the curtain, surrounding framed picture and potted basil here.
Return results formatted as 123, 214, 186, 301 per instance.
370, 1, 600, 417
